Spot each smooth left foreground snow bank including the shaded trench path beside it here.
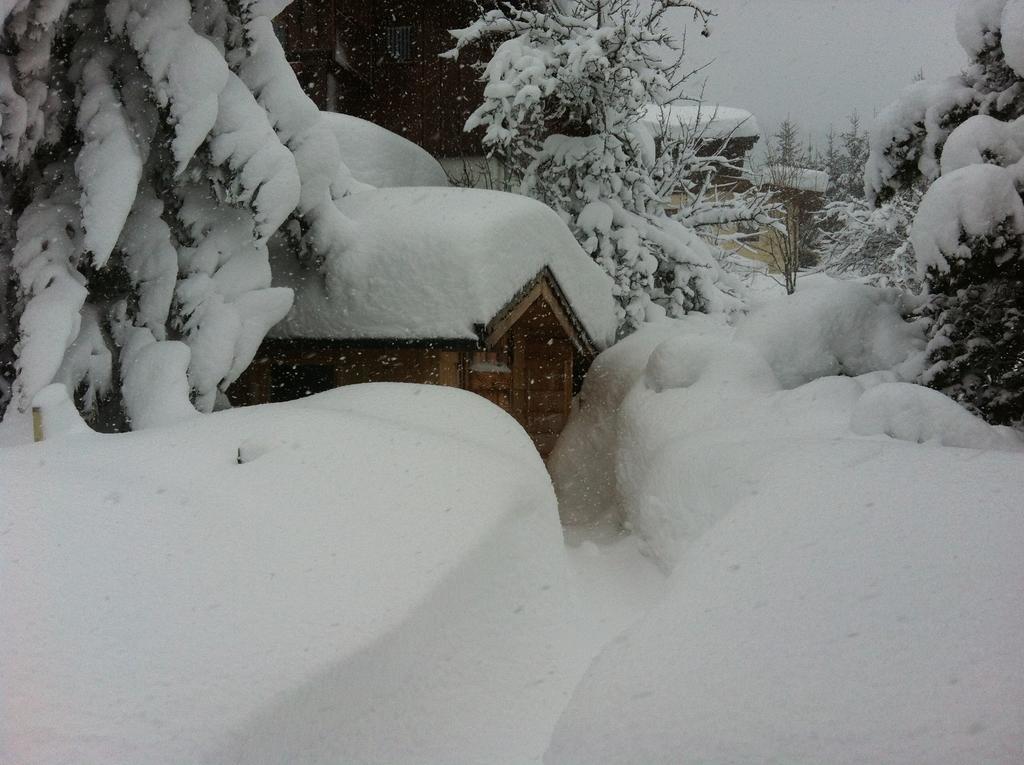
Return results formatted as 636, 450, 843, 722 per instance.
0, 384, 586, 765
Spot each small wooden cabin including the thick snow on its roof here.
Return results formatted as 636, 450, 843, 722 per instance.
229, 188, 616, 457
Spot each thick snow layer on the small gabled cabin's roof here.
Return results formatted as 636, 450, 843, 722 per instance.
270, 188, 616, 348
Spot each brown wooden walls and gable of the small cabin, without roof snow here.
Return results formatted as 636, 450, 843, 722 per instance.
232, 269, 597, 457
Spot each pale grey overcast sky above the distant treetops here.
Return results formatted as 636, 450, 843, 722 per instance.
678, 0, 967, 151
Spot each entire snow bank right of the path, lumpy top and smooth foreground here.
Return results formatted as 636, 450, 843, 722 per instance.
546, 277, 1024, 765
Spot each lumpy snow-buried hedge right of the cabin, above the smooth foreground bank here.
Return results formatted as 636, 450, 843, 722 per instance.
549, 275, 1021, 567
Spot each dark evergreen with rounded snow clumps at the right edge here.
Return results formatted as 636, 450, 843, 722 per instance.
865, 0, 1024, 427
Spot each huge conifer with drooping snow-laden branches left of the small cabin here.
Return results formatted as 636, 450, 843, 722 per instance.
0, 0, 350, 428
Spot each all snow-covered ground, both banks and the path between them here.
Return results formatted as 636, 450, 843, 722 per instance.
0, 277, 1024, 764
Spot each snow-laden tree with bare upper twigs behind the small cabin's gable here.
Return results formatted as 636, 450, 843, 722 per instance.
449, 0, 738, 332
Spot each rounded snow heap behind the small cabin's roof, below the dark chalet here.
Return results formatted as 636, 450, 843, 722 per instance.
323, 112, 447, 188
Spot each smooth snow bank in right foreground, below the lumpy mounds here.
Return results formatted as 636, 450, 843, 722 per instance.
545, 434, 1024, 765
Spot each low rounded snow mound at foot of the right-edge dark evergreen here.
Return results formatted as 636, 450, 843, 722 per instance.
850, 383, 1024, 450
